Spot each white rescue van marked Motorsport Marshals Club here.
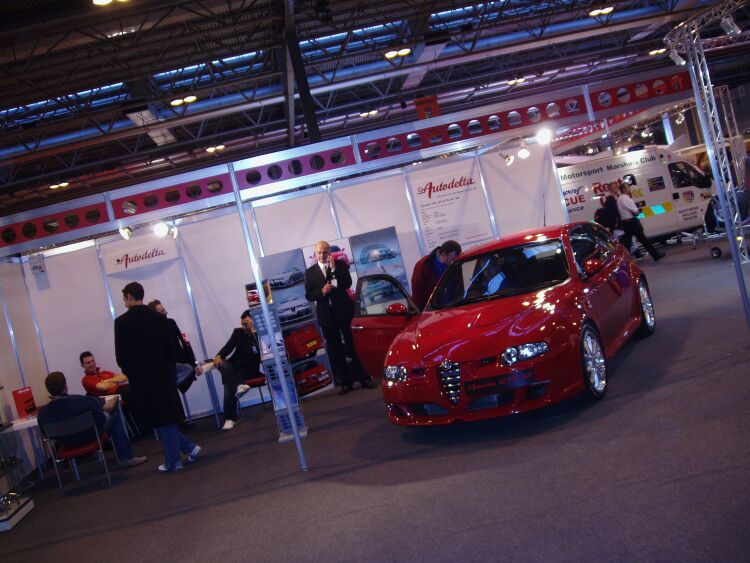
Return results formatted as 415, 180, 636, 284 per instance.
557, 146, 715, 238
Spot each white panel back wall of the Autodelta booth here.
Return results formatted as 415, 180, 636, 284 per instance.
0, 145, 567, 428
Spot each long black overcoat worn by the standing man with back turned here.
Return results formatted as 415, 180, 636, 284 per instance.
115, 305, 183, 428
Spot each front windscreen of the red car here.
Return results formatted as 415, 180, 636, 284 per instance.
429, 239, 570, 309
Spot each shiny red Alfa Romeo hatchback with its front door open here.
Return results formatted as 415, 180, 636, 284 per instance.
352, 222, 655, 426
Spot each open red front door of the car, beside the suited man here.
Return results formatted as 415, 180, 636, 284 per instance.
352, 274, 420, 379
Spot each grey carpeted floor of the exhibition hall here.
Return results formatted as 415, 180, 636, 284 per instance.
0, 243, 750, 563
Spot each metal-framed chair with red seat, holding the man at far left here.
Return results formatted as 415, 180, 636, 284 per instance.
40, 412, 120, 495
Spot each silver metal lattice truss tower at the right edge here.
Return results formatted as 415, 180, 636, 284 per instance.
664, 0, 750, 327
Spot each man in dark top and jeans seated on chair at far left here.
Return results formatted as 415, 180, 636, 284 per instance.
37, 371, 148, 467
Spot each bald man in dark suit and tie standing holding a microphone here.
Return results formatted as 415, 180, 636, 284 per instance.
305, 240, 374, 395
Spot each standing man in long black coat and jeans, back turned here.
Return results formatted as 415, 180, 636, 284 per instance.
115, 282, 201, 471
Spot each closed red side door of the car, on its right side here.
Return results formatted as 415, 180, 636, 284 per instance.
570, 223, 632, 347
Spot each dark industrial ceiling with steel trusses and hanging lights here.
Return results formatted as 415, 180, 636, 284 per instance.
0, 0, 750, 215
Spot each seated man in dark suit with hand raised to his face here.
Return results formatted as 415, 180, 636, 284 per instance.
214, 309, 261, 430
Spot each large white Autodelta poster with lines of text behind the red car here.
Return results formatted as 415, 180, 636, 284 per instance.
408, 158, 493, 252
